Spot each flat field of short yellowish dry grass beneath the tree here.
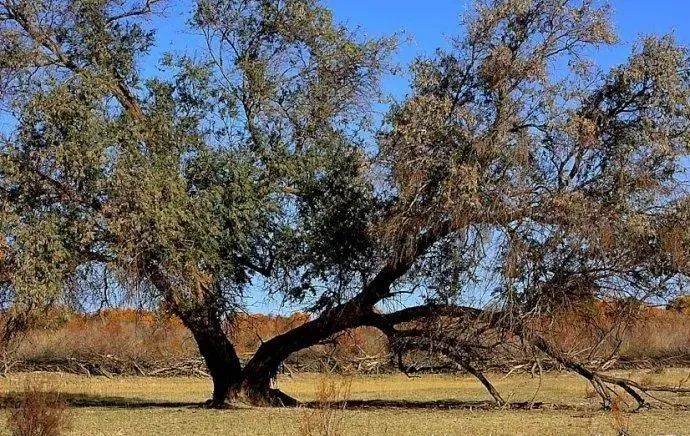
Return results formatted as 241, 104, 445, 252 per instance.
0, 369, 690, 436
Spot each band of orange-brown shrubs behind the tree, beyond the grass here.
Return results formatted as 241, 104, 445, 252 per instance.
5, 302, 690, 370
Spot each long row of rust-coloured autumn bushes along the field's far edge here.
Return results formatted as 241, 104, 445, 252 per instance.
5, 305, 690, 376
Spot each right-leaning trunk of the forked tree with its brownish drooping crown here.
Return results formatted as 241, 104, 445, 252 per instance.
228, 0, 690, 408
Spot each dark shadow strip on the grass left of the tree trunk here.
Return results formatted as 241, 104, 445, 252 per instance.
0, 393, 205, 409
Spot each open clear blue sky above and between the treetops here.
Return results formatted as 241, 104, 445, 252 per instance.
153, 0, 690, 102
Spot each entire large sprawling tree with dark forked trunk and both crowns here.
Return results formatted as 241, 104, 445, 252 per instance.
0, 0, 690, 405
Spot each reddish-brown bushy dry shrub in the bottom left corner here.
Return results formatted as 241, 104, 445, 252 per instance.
7, 387, 72, 436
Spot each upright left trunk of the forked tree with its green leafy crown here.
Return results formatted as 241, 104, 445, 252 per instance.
0, 0, 392, 406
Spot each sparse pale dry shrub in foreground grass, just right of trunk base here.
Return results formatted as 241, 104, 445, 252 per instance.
299, 377, 352, 436
